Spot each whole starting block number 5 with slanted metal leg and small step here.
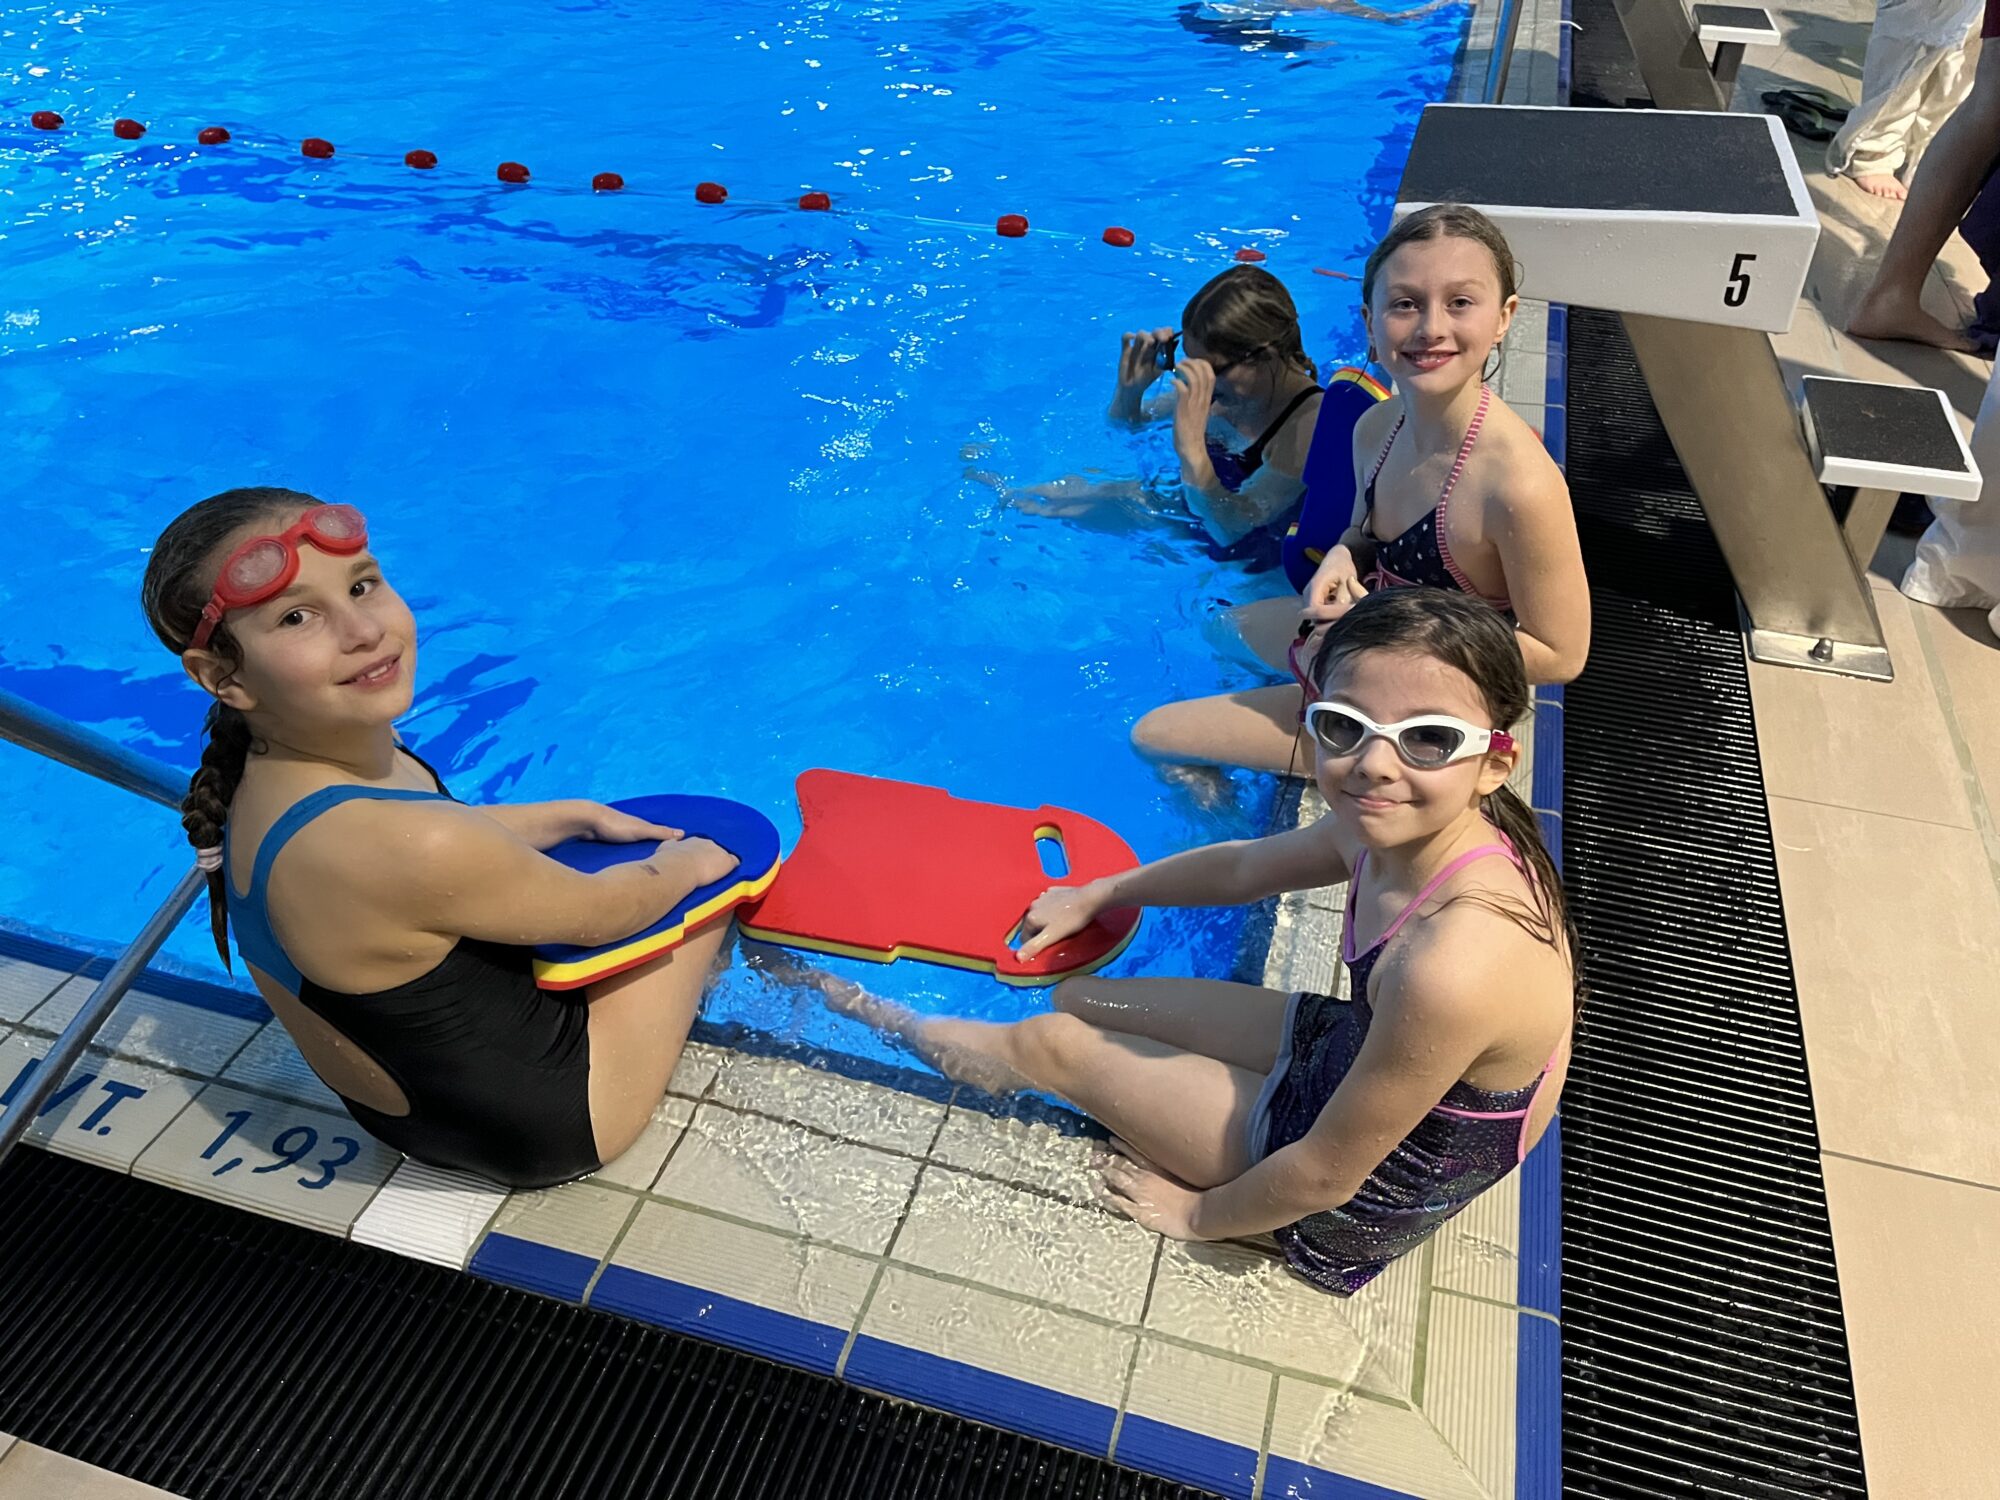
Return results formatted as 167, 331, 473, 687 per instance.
1396, 98, 1980, 678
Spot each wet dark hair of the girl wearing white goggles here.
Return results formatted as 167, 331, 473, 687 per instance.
1312, 588, 1584, 1006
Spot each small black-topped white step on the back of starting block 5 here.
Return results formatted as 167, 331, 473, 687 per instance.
1804, 376, 1980, 500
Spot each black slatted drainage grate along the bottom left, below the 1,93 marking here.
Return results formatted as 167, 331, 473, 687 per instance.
0, 1148, 1204, 1500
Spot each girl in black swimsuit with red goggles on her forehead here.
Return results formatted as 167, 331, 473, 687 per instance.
142, 488, 736, 1188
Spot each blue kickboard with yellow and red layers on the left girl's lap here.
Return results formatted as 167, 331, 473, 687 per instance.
534, 796, 780, 990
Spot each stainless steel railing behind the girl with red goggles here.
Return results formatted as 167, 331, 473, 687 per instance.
0, 690, 208, 1162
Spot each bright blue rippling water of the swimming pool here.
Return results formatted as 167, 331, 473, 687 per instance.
0, 0, 1466, 1056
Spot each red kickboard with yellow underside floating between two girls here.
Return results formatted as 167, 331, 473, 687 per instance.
738, 770, 1140, 984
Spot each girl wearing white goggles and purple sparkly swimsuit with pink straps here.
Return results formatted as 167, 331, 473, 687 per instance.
826, 588, 1578, 1296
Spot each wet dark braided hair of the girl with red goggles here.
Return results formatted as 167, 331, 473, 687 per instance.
140, 486, 320, 968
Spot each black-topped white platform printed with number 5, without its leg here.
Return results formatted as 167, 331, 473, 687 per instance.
1396, 104, 1820, 332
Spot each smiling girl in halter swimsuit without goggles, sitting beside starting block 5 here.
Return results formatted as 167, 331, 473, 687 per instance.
1132, 204, 1590, 772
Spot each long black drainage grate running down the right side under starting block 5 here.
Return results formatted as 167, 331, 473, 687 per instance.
1562, 308, 1864, 1500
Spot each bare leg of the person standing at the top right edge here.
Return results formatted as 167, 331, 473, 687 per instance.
1848, 39, 2000, 352
